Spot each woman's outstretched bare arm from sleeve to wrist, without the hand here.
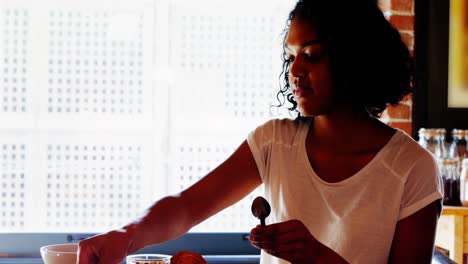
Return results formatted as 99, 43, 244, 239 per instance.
129, 141, 262, 252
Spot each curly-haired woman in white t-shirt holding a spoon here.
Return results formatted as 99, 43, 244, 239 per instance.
79, 0, 442, 264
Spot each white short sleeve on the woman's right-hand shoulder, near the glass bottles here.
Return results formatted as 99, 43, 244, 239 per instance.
398, 153, 443, 220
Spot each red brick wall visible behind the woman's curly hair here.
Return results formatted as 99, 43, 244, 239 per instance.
378, 0, 414, 135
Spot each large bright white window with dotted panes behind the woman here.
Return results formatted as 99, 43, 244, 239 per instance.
0, 0, 291, 235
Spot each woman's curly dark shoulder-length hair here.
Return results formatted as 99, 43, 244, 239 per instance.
277, 0, 413, 117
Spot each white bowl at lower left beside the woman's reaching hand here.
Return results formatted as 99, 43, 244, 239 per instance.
41, 243, 78, 264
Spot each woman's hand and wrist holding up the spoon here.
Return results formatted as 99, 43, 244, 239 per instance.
250, 220, 347, 264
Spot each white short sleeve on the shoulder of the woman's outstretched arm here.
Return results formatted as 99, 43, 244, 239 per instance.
247, 120, 274, 180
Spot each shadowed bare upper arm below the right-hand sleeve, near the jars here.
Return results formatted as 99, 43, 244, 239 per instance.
388, 200, 440, 264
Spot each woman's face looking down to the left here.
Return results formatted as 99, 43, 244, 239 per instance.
285, 18, 333, 116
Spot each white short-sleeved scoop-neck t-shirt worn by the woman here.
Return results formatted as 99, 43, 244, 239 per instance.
247, 119, 442, 264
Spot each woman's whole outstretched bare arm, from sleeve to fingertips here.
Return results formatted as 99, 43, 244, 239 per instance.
79, 141, 262, 264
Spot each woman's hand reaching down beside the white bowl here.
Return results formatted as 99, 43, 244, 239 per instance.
78, 225, 133, 264
